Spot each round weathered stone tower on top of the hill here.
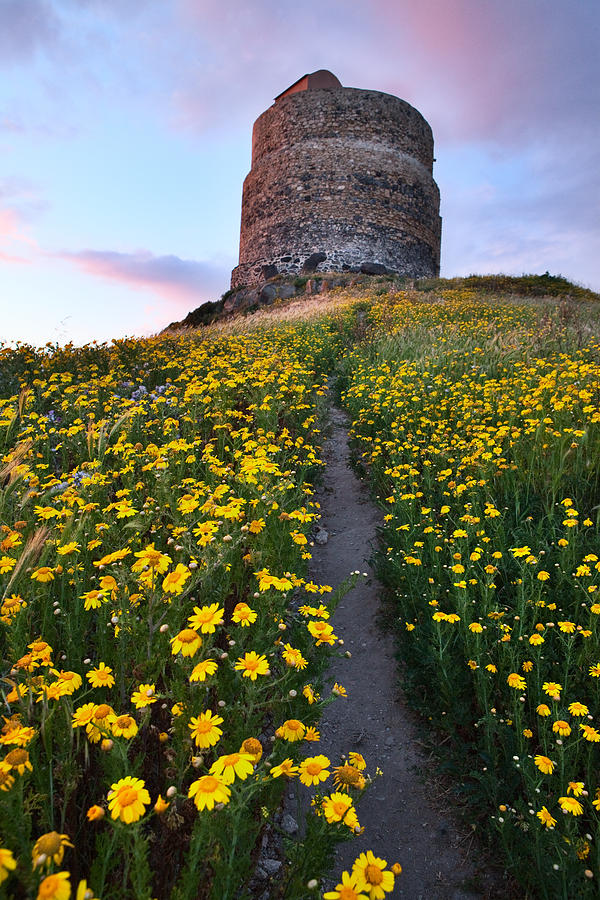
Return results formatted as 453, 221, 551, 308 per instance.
231, 69, 441, 288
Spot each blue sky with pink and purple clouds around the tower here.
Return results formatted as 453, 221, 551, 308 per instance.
0, 0, 600, 345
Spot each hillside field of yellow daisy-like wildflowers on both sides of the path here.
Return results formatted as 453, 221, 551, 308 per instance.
0, 281, 600, 900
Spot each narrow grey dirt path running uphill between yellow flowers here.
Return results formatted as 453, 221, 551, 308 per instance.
311, 409, 484, 900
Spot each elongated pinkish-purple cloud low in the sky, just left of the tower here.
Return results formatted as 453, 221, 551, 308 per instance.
55, 250, 230, 318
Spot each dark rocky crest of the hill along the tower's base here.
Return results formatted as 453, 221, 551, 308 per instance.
164, 272, 600, 331
